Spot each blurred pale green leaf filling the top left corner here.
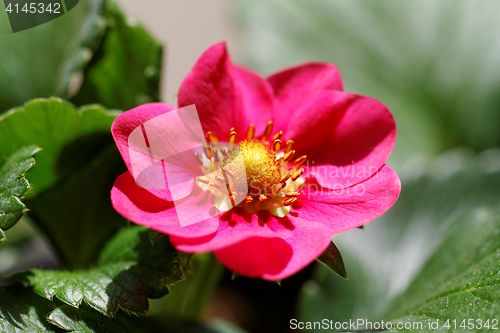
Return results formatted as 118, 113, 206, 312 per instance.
0, 0, 105, 113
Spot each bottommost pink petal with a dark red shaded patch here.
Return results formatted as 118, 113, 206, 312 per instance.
214, 217, 332, 281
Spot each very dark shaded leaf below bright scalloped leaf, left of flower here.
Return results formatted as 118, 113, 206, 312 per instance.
26, 144, 125, 269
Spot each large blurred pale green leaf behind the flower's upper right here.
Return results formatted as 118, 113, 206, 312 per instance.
239, 0, 500, 161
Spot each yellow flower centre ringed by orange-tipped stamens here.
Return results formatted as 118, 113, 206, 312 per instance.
194, 121, 307, 217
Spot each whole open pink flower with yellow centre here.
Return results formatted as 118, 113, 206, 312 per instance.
111, 44, 401, 280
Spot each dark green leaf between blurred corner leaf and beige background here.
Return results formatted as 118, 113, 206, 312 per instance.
72, 1, 162, 110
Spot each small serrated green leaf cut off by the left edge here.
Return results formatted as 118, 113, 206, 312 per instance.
0, 146, 40, 239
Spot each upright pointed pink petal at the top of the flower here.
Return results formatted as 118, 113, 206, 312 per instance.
179, 43, 273, 141
